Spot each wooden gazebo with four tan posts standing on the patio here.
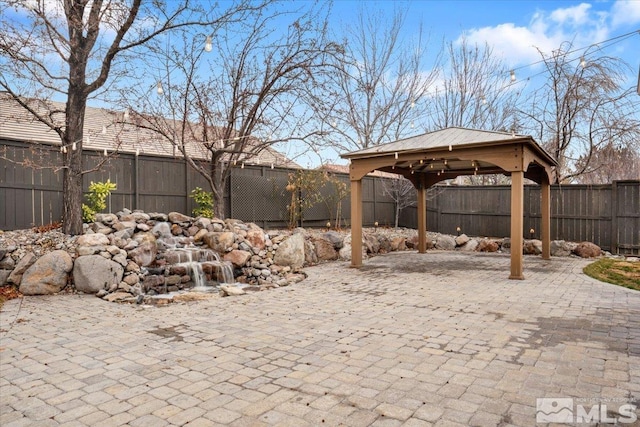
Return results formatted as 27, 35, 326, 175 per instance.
341, 127, 558, 279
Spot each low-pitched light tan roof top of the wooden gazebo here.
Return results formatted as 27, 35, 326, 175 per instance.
341, 127, 556, 164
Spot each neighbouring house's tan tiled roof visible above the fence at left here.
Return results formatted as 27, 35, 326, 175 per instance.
0, 92, 301, 169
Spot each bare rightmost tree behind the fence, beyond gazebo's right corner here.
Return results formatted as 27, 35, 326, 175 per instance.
521, 43, 640, 183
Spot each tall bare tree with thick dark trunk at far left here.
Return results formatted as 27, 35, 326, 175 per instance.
0, 0, 260, 234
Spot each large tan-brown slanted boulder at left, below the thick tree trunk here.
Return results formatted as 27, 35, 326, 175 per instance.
20, 250, 73, 295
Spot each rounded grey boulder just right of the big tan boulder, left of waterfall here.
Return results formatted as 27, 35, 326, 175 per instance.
73, 255, 124, 294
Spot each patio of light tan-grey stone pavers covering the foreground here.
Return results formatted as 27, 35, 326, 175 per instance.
0, 252, 640, 427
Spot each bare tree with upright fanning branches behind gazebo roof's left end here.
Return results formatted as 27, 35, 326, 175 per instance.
312, 5, 442, 151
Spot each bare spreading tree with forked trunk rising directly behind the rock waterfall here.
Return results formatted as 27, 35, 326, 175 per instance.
130, 5, 341, 218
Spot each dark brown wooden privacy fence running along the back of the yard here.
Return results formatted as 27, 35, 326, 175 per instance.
0, 141, 640, 254
